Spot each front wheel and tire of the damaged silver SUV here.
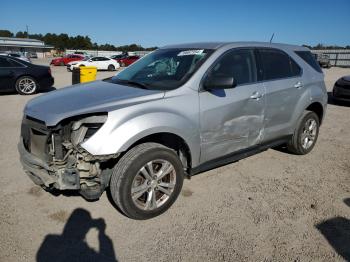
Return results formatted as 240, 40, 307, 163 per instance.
110, 143, 184, 219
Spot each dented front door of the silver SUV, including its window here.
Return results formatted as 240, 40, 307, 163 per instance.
199, 49, 265, 163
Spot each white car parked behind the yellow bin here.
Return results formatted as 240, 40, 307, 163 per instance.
67, 56, 120, 71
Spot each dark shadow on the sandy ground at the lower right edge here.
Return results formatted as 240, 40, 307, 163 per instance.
315, 198, 350, 261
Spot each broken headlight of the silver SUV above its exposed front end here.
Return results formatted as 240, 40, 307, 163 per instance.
71, 114, 107, 145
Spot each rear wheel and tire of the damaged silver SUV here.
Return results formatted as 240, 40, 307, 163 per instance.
287, 111, 320, 155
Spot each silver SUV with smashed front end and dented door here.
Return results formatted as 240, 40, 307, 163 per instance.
19, 42, 327, 219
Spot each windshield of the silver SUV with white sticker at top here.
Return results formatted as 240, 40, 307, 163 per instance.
111, 48, 212, 90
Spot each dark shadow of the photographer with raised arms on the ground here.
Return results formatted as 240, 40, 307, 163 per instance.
36, 208, 117, 262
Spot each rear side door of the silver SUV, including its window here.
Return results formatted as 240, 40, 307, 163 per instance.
258, 48, 303, 141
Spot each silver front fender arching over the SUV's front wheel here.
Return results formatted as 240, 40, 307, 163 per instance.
81, 110, 200, 165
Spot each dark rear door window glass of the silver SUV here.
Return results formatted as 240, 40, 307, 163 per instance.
259, 49, 301, 80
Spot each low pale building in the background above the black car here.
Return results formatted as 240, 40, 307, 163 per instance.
0, 37, 54, 58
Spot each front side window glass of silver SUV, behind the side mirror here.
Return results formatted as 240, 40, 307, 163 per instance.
208, 49, 257, 85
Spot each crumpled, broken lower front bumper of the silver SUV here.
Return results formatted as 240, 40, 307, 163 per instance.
18, 137, 80, 190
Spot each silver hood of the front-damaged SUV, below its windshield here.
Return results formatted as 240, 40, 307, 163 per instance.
24, 80, 164, 126
